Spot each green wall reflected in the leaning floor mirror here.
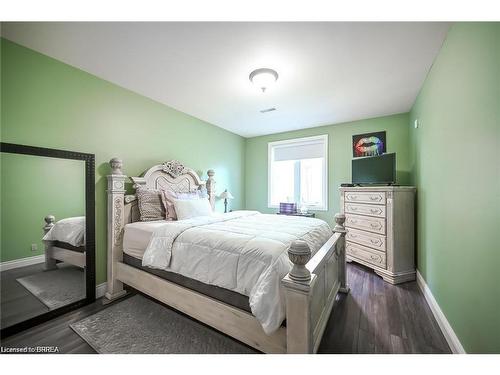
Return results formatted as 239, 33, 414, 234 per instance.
0, 153, 85, 262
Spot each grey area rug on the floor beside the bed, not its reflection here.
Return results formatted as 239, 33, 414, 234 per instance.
70, 295, 255, 354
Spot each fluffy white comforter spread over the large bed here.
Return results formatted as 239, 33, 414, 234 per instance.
142, 211, 332, 334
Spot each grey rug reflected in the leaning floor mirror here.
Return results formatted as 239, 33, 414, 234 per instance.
16, 265, 85, 310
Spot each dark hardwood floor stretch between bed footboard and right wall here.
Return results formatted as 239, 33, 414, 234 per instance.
319, 263, 450, 354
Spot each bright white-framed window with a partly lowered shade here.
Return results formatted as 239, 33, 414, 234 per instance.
268, 134, 328, 211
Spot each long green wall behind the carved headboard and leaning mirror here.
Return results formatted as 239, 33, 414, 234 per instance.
1, 39, 245, 283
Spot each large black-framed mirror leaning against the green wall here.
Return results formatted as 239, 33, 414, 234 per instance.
0, 143, 95, 336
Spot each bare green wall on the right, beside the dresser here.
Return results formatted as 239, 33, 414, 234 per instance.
410, 23, 500, 353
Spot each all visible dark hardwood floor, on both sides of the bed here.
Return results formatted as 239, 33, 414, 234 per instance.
1, 263, 450, 353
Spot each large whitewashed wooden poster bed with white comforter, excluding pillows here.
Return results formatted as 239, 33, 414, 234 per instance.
105, 158, 348, 353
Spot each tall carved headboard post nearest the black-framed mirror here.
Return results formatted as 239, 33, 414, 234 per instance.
104, 158, 127, 301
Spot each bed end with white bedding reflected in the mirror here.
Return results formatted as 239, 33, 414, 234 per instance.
42, 215, 86, 270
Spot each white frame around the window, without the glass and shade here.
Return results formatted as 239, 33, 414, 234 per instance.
267, 134, 328, 211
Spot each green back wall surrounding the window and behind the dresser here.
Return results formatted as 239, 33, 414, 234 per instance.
245, 113, 410, 224
